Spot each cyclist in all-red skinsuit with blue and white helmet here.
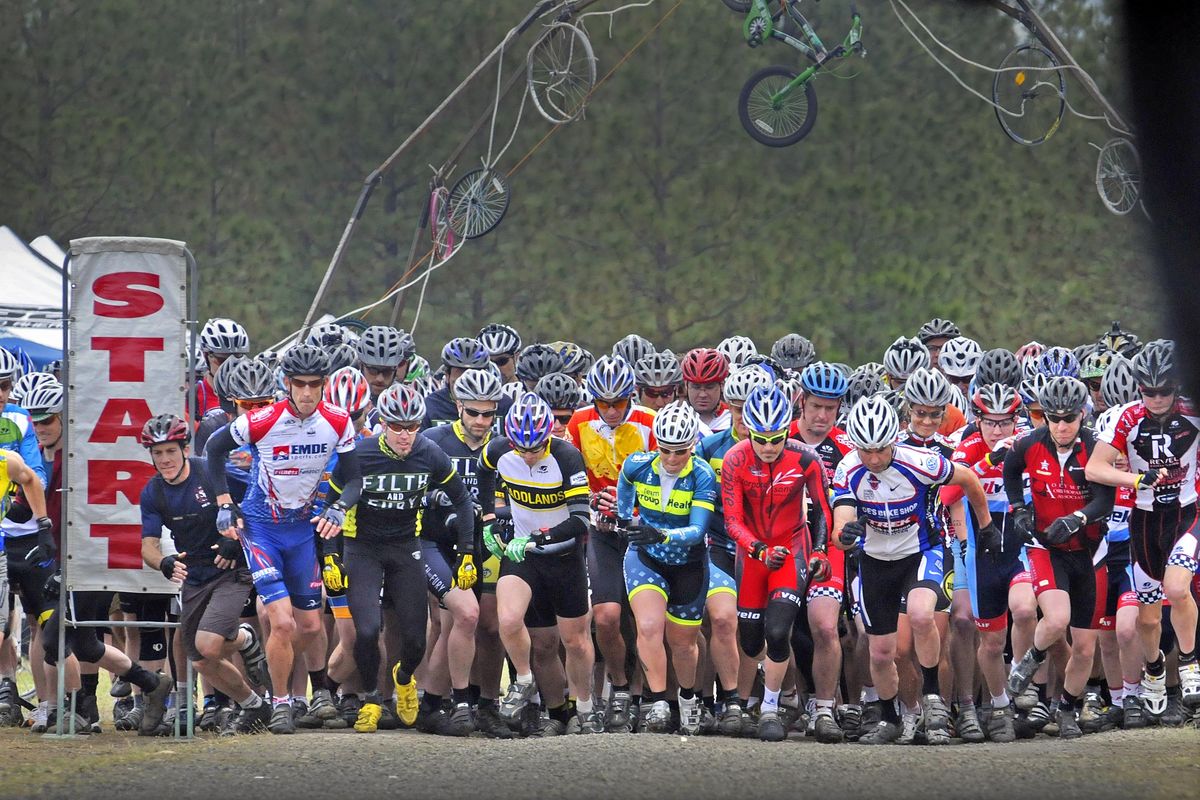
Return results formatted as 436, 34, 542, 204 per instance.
721, 386, 841, 741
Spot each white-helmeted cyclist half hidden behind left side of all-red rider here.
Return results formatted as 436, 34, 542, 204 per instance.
696, 366, 772, 736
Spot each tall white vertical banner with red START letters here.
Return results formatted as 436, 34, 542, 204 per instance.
62, 236, 190, 593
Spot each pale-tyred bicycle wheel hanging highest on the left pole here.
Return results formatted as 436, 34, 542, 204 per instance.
526, 23, 596, 125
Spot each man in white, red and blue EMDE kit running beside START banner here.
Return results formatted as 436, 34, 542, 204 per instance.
205, 344, 361, 734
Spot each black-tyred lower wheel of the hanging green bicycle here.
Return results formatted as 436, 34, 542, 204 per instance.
738, 66, 817, 148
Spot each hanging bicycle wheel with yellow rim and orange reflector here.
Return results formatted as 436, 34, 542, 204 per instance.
991, 44, 1067, 145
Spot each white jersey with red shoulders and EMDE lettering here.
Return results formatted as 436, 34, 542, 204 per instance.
229, 401, 355, 522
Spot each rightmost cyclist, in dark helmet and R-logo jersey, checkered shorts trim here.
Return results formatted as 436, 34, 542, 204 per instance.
1087, 339, 1200, 716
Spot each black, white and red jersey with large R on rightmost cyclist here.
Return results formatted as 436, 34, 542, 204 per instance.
1098, 397, 1200, 511
